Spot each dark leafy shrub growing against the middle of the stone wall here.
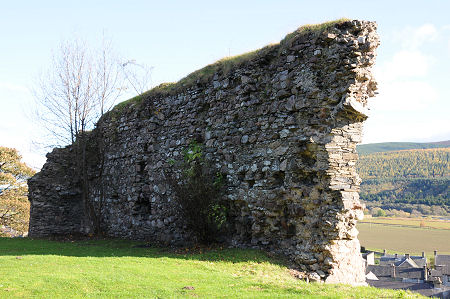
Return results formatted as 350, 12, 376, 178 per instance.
168, 142, 229, 244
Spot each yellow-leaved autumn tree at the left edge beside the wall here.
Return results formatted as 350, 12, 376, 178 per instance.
0, 146, 35, 235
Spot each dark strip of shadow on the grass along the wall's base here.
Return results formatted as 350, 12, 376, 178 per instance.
0, 237, 287, 266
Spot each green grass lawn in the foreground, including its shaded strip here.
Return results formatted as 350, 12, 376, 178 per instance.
0, 238, 418, 298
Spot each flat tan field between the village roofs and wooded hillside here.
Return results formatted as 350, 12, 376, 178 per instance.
357, 218, 450, 256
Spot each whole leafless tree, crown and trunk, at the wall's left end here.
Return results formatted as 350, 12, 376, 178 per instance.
34, 36, 154, 234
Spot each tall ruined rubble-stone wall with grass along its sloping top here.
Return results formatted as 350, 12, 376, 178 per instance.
29, 21, 379, 284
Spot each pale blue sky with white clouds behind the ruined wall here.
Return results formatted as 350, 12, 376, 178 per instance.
0, 0, 450, 167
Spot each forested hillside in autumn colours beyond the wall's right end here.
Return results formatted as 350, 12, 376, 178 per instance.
357, 148, 450, 215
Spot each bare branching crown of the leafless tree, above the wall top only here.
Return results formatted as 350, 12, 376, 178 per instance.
34, 38, 124, 145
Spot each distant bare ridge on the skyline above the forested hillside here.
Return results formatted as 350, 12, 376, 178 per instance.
356, 140, 450, 155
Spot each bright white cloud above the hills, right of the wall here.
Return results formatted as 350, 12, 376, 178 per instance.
363, 24, 450, 143
